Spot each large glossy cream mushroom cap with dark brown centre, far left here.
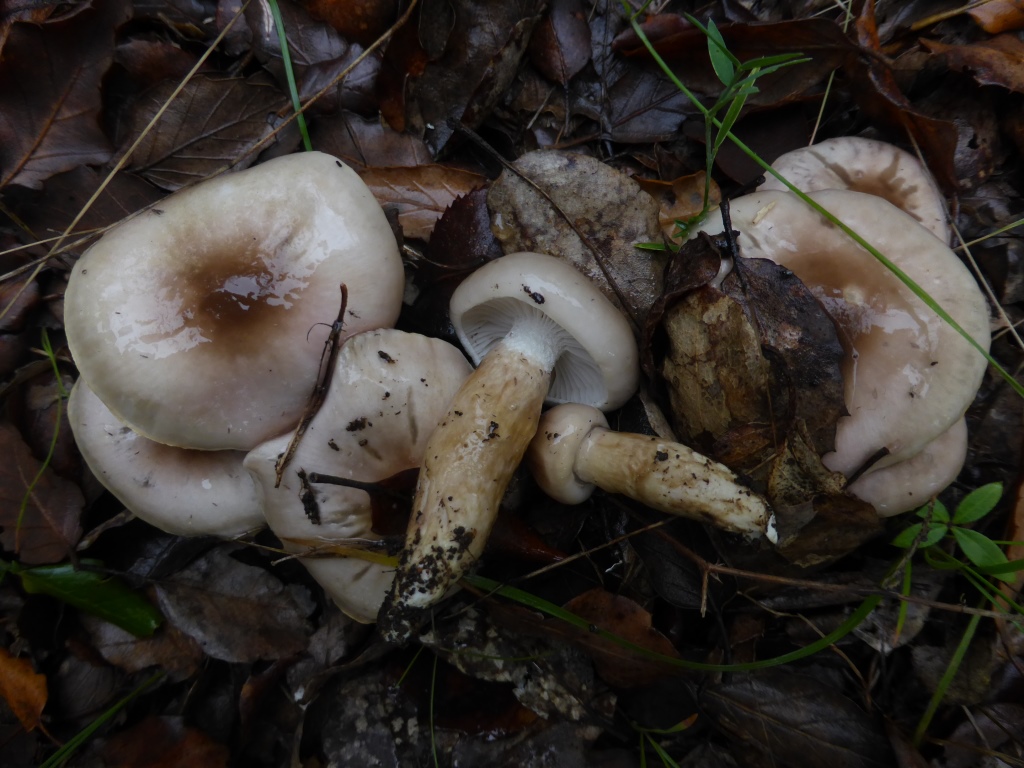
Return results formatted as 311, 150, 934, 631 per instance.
65, 153, 404, 450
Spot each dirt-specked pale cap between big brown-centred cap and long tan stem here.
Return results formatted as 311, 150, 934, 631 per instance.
245, 329, 472, 622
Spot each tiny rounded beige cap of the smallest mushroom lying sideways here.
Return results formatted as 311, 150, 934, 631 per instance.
526, 402, 608, 504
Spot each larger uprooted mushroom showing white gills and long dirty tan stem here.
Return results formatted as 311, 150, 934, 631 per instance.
380, 253, 639, 642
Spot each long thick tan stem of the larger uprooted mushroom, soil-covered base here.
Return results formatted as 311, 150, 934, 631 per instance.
378, 335, 558, 642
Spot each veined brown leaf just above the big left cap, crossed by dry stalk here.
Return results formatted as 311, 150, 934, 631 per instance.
121, 75, 286, 191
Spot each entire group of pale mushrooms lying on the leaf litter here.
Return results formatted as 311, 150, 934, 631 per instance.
65, 142, 988, 642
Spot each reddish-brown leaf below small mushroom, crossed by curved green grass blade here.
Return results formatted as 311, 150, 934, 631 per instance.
563, 589, 679, 688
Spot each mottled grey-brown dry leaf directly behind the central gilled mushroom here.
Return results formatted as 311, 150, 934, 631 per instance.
487, 151, 664, 325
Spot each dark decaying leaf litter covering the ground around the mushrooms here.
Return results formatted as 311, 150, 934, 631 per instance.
0, 0, 1024, 766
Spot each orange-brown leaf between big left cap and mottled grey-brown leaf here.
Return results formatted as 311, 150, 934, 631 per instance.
358, 165, 486, 240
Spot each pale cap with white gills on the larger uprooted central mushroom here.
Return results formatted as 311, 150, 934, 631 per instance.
450, 252, 640, 411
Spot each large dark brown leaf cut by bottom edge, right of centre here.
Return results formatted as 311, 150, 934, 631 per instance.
702, 670, 894, 768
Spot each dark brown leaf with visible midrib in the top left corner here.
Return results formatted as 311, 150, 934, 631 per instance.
0, 0, 129, 189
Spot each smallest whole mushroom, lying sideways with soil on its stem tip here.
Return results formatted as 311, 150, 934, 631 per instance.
526, 403, 774, 539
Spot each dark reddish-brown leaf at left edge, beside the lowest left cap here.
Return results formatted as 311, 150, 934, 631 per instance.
0, 424, 85, 565
